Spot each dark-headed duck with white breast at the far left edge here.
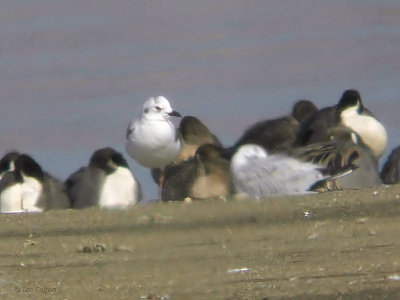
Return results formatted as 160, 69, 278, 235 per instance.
0, 154, 47, 213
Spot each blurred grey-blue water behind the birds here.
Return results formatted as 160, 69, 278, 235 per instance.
0, 0, 400, 199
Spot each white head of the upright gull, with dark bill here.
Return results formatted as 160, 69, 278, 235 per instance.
143, 96, 181, 120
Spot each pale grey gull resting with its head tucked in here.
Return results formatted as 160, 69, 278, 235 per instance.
231, 144, 352, 198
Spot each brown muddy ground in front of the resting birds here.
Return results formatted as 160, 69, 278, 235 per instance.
0, 186, 400, 299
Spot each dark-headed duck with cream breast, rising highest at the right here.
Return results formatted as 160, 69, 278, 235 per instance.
294, 90, 388, 158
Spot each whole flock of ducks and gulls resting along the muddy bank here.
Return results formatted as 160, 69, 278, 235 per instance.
0, 90, 400, 213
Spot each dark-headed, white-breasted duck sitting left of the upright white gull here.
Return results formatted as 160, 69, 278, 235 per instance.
65, 147, 142, 209
